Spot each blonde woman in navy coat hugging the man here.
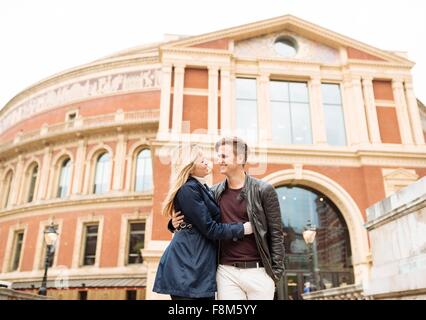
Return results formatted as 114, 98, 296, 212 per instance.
153, 145, 252, 300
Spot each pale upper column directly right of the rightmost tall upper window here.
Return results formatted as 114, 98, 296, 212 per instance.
352, 77, 369, 144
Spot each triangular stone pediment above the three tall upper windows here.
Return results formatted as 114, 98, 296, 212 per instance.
166, 15, 414, 67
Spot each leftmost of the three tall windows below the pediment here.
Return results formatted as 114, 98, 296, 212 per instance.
235, 78, 257, 141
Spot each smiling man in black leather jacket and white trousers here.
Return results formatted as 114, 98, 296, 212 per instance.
169, 137, 284, 300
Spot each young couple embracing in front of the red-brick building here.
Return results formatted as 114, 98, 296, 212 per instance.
153, 137, 284, 300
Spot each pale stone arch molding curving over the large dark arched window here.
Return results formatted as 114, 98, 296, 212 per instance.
262, 169, 369, 283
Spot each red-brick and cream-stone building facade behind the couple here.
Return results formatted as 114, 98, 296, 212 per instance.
0, 16, 426, 299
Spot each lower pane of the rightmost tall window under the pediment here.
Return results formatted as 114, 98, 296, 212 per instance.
324, 105, 346, 146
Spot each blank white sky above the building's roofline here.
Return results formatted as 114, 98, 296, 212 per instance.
0, 0, 426, 108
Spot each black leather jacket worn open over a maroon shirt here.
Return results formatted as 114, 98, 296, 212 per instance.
211, 174, 284, 282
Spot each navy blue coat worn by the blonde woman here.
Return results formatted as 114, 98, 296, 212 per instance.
153, 177, 244, 298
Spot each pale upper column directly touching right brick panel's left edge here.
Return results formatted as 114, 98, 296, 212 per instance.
362, 77, 381, 144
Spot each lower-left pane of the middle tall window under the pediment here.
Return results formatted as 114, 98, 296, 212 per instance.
271, 102, 291, 144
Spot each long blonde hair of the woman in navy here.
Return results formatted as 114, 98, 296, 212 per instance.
162, 144, 203, 217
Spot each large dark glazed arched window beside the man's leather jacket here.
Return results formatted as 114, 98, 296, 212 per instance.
276, 186, 354, 299
